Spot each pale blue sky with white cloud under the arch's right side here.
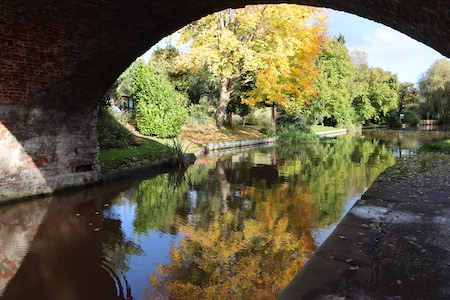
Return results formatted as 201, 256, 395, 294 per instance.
327, 9, 444, 83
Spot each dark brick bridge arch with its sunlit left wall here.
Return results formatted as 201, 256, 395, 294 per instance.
0, 0, 450, 200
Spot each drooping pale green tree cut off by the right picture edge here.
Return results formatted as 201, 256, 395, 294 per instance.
419, 58, 450, 123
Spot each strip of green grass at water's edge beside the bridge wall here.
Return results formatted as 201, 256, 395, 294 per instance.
100, 139, 173, 173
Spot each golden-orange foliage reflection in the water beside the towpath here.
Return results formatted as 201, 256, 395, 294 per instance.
147, 200, 314, 299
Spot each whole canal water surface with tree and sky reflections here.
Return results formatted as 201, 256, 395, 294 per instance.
0, 130, 450, 300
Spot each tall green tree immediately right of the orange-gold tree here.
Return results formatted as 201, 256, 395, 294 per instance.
310, 36, 355, 125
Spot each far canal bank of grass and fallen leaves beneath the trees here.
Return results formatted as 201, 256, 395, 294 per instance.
99, 111, 344, 174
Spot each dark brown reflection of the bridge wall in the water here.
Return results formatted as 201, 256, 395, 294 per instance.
0, 189, 132, 299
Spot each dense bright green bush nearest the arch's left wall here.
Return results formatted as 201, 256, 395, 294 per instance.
131, 62, 187, 138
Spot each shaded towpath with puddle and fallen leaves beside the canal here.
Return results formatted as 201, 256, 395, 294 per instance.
280, 153, 450, 299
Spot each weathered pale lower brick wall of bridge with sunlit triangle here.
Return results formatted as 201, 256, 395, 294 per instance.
0, 105, 100, 200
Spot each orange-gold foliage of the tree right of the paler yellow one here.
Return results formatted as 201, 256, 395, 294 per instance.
244, 6, 326, 123
